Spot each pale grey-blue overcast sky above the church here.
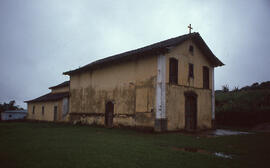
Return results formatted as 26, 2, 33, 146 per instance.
0, 0, 270, 107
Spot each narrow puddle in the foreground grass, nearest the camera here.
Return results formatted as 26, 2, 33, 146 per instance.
172, 147, 232, 159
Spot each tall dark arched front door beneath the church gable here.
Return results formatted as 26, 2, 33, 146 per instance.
185, 91, 197, 130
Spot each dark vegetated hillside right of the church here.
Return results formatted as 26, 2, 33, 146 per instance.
215, 81, 270, 126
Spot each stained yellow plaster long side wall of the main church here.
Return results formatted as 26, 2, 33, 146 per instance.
70, 57, 157, 127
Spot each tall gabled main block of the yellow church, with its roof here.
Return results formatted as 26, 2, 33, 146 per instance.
63, 33, 224, 131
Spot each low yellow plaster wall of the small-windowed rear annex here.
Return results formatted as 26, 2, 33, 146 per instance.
27, 100, 64, 121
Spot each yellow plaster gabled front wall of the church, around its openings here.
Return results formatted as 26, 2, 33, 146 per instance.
166, 41, 213, 130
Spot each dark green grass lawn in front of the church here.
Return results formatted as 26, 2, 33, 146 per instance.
0, 122, 270, 168
